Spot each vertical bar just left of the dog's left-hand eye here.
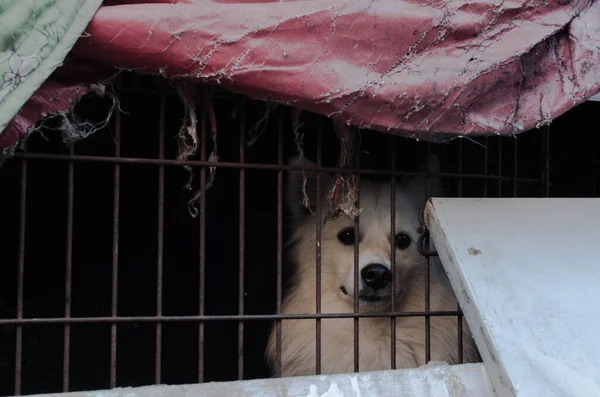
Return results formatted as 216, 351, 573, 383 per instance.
315, 118, 323, 375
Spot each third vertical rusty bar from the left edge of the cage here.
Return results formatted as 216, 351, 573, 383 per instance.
110, 99, 121, 389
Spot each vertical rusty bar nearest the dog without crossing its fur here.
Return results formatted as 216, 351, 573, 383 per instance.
238, 104, 246, 380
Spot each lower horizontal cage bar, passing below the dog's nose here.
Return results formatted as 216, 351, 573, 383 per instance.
0, 311, 460, 325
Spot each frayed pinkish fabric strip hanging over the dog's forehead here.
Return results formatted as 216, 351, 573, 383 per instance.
329, 123, 362, 219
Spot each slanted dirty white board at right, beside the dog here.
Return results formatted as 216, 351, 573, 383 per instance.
426, 199, 600, 397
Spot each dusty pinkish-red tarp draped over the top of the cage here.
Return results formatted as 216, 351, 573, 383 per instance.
0, 0, 600, 149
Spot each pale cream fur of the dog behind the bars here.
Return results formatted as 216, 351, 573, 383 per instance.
267, 153, 479, 376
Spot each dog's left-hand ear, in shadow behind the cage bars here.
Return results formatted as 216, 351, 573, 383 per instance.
285, 157, 333, 217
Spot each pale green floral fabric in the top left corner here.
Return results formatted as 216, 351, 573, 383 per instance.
0, 0, 102, 134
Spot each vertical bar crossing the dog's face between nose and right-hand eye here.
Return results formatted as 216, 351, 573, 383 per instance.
390, 135, 397, 369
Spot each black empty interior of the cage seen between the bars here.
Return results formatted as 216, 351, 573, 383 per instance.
0, 74, 600, 395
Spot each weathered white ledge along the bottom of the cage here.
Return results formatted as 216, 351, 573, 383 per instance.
11, 363, 494, 397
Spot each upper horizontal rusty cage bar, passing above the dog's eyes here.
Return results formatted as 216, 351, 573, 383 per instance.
13, 153, 540, 184
